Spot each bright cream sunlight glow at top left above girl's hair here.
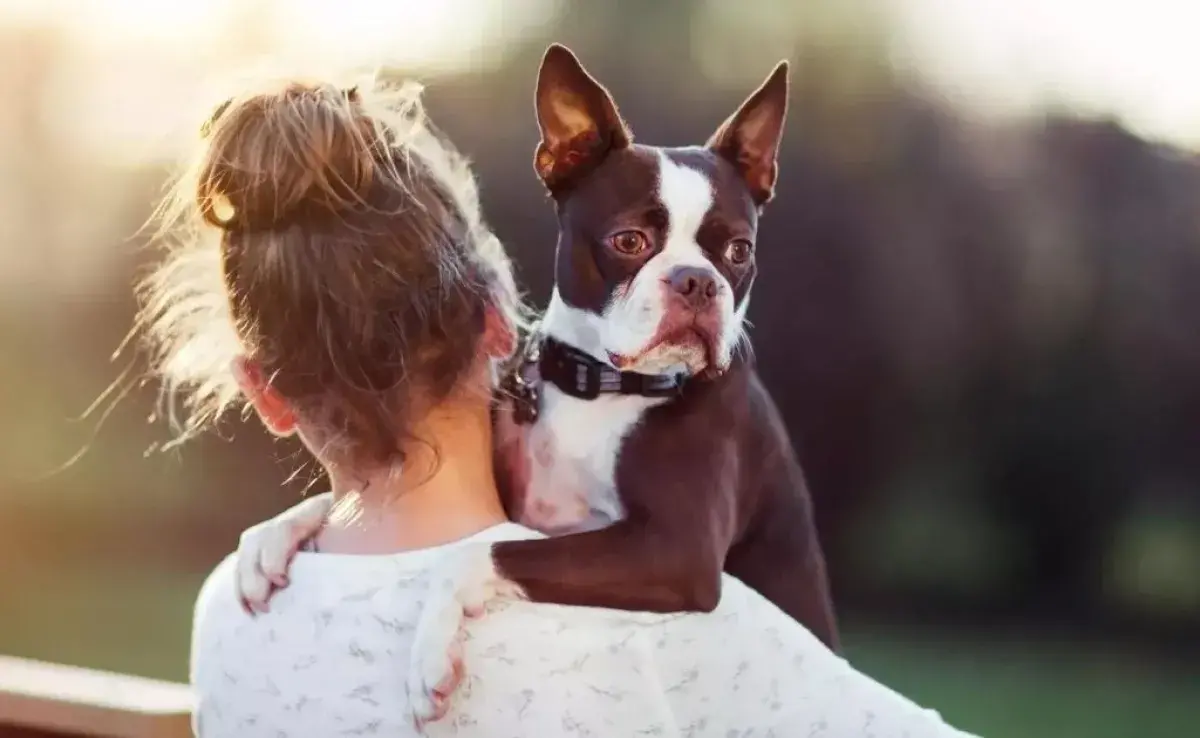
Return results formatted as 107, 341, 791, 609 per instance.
0, 0, 557, 164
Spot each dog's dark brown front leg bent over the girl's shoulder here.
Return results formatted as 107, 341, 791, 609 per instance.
492, 430, 738, 612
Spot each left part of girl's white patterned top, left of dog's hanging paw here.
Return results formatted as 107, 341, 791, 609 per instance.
192, 524, 524, 738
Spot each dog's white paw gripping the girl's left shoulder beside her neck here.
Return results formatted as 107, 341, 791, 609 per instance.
235, 493, 334, 614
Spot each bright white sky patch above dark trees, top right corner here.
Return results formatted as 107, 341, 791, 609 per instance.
890, 0, 1200, 146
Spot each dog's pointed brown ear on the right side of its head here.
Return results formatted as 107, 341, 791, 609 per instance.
708, 61, 787, 206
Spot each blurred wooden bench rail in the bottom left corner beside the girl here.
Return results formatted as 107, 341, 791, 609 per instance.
0, 656, 193, 738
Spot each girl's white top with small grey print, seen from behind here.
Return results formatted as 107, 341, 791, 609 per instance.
192, 523, 966, 738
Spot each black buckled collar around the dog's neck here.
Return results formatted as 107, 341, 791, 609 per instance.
503, 336, 688, 424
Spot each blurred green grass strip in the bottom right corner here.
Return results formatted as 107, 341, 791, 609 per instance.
847, 626, 1200, 738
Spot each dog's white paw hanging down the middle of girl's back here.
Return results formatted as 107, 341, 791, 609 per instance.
408, 546, 523, 726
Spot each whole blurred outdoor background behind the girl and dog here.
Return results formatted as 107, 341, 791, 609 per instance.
0, 0, 1200, 738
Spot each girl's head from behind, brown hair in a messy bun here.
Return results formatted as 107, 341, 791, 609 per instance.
142, 82, 520, 466
